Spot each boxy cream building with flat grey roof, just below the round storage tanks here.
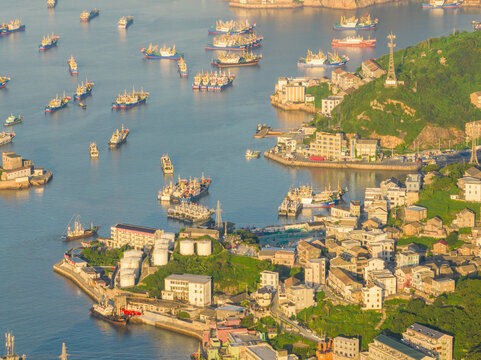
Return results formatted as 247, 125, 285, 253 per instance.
162, 274, 212, 306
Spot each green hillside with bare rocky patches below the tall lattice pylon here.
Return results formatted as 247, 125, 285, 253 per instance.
333, 32, 481, 145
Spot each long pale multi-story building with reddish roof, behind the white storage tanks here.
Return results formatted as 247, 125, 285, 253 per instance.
102, 224, 164, 250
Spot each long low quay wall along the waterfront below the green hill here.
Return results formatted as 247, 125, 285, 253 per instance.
264, 151, 419, 171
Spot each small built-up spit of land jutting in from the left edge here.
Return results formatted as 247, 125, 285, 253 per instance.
0, 151, 53, 190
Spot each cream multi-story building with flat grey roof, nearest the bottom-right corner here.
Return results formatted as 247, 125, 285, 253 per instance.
402, 323, 453, 360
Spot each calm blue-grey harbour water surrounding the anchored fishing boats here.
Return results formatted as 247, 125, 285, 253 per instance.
0, 0, 481, 360
